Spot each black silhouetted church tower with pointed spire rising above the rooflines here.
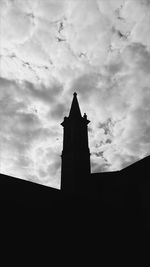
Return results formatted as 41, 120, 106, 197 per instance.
61, 93, 90, 194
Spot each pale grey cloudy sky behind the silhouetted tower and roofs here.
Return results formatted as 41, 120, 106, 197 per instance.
0, 0, 150, 188
